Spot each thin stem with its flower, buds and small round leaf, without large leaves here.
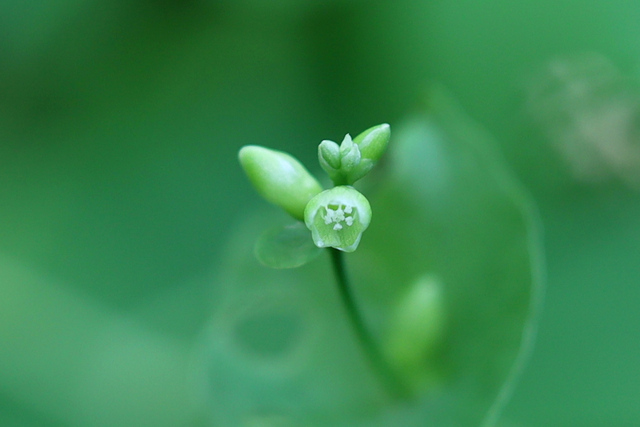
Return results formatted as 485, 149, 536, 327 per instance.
239, 124, 416, 398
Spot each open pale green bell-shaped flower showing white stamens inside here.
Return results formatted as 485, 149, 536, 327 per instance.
304, 186, 371, 252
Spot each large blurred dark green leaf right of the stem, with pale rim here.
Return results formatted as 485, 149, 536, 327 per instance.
353, 88, 540, 426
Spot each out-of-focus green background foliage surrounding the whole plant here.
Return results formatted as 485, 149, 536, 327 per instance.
0, 0, 640, 427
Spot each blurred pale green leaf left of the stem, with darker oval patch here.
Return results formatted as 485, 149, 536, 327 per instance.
200, 215, 386, 426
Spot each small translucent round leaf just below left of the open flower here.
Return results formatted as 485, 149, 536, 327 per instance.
254, 221, 321, 268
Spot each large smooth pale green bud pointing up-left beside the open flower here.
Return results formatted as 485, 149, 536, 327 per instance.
238, 145, 322, 221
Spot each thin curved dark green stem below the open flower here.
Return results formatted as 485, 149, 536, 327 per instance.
330, 248, 407, 399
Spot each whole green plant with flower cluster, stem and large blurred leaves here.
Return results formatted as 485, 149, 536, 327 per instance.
209, 90, 539, 426
